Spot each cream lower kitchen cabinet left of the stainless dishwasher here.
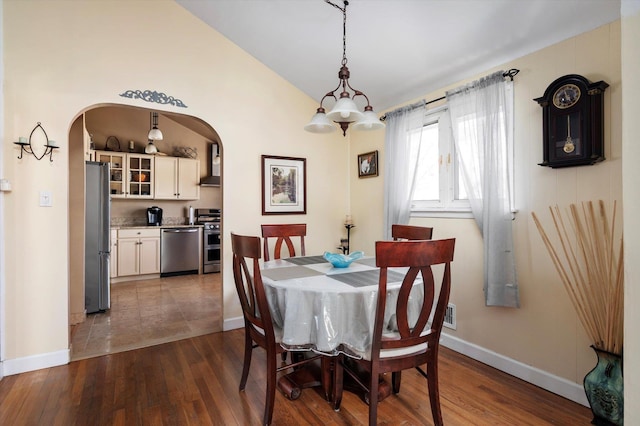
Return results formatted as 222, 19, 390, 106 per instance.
117, 228, 160, 277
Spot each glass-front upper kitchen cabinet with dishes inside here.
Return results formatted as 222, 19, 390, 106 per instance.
96, 151, 155, 199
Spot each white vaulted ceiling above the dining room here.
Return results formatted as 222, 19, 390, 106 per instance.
176, 0, 620, 112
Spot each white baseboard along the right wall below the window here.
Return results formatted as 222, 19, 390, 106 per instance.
440, 333, 589, 407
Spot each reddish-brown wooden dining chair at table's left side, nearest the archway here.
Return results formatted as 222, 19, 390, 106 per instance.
231, 233, 318, 425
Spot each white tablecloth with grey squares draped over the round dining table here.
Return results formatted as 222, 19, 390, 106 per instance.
261, 256, 423, 358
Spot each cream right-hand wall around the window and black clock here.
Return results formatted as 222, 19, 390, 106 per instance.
349, 22, 622, 385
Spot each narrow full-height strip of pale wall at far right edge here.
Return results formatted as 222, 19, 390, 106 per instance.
621, 0, 640, 425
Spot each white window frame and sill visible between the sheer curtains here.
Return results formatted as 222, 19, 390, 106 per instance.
411, 105, 473, 218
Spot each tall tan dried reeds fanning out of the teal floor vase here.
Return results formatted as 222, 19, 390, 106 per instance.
531, 200, 624, 355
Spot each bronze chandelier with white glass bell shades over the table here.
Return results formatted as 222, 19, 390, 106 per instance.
304, 0, 384, 136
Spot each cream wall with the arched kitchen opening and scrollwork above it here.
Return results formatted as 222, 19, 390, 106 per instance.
2, 0, 347, 366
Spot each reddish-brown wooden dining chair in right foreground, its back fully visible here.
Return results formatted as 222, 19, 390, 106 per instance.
332, 239, 455, 426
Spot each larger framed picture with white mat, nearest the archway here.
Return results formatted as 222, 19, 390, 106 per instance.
262, 155, 307, 215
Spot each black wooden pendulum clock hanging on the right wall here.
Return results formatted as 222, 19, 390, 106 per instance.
534, 74, 609, 168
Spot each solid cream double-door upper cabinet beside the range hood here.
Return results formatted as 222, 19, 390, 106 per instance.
154, 157, 200, 200
